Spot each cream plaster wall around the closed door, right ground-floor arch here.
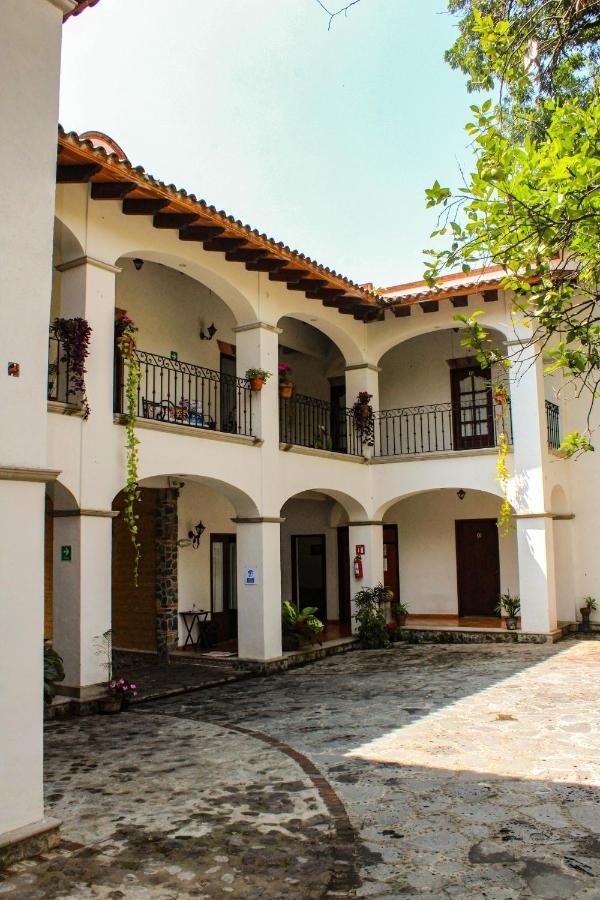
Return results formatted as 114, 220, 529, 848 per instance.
384, 491, 519, 615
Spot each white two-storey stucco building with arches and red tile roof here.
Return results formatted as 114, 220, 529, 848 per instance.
0, 0, 600, 864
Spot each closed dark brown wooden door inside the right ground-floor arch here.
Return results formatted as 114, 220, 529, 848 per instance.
456, 519, 500, 616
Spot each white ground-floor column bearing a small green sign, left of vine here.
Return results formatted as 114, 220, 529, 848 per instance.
53, 509, 114, 698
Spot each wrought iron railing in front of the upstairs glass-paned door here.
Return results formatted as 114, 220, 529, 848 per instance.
374, 403, 512, 456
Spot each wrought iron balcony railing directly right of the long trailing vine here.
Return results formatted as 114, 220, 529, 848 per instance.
115, 350, 252, 435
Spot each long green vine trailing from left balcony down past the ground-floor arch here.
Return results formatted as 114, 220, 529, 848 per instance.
115, 314, 142, 587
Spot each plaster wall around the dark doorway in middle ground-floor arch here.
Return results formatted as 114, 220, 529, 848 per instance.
281, 496, 339, 619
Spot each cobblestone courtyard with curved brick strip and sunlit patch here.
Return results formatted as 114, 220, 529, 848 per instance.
0, 640, 600, 900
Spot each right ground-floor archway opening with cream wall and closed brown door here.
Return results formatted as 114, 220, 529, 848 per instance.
381, 486, 519, 627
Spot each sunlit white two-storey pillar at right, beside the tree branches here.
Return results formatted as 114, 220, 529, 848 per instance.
509, 342, 556, 632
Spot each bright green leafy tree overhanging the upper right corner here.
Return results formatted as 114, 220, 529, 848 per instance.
425, 0, 600, 453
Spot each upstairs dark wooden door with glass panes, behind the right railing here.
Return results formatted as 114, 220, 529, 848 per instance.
450, 364, 494, 450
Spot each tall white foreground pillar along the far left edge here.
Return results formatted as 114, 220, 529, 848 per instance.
0, 0, 75, 852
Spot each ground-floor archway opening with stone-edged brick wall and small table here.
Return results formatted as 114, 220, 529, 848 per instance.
112, 473, 258, 655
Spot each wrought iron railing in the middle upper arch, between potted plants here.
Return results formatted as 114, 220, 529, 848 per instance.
279, 394, 363, 456
